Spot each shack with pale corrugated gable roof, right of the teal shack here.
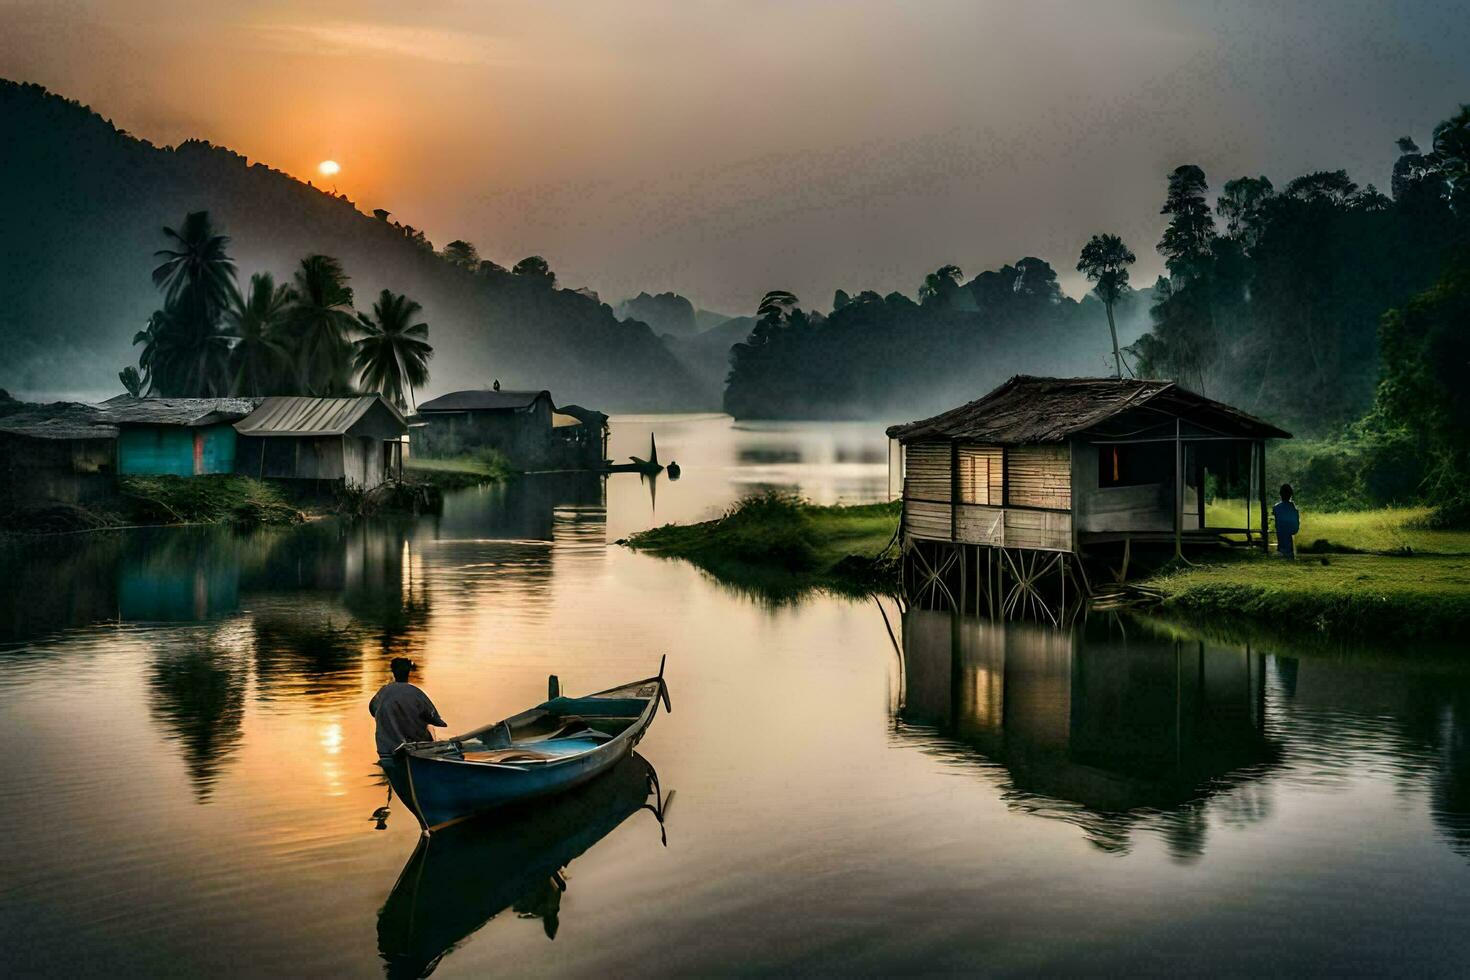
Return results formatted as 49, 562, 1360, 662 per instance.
235, 395, 409, 489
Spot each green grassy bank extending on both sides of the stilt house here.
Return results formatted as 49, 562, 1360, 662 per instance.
617, 494, 1470, 642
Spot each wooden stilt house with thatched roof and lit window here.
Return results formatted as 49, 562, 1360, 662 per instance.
888, 376, 1291, 617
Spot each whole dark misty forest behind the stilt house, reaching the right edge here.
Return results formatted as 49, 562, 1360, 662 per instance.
725, 110, 1470, 435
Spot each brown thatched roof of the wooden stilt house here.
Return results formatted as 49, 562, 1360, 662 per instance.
888, 375, 1291, 445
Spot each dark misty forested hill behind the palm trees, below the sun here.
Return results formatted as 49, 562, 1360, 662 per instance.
0, 79, 711, 410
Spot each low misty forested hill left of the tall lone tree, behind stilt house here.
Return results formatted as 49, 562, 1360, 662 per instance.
725, 265, 1152, 419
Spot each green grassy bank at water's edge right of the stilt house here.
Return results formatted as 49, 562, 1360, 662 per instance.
1145, 554, 1470, 641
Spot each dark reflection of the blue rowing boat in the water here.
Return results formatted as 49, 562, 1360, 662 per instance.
375, 752, 673, 977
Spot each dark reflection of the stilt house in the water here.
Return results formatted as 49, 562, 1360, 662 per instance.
898, 610, 1280, 860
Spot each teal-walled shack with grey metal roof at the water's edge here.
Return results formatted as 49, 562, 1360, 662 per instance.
101, 395, 259, 476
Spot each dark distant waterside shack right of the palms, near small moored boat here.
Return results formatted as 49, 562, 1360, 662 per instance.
413, 389, 607, 470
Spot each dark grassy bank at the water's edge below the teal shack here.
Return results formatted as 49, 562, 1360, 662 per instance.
118, 475, 303, 525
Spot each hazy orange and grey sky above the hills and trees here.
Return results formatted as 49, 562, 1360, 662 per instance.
0, 0, 1470, 313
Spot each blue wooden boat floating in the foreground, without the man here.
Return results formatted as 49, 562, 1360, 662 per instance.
384, 661, 669, 833
